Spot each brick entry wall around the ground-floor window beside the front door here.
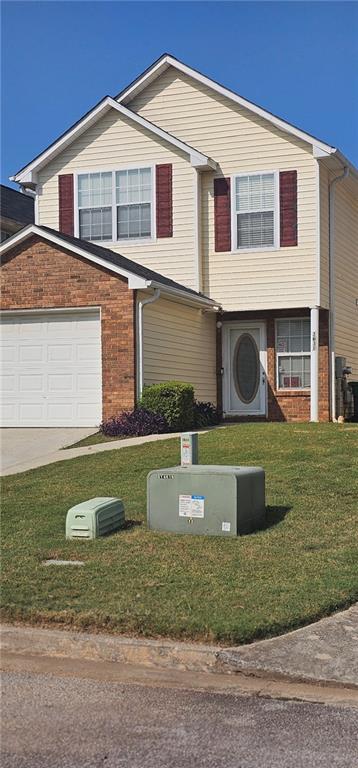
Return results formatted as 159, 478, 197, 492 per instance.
222, 309, 329, 421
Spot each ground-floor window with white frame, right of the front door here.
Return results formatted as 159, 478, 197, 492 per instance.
276, 318, 311, 389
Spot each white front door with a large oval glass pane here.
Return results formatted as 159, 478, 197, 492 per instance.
223, 323, 267, 416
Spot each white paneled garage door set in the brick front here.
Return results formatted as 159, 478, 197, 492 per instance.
1, 310, 102, 427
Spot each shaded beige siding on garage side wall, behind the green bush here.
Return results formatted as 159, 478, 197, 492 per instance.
139, 294, 216, 403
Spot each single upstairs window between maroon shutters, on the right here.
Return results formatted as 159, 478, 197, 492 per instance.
233, 173, 278, 250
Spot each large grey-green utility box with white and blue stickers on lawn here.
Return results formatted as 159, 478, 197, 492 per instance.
147, 464, 265, 536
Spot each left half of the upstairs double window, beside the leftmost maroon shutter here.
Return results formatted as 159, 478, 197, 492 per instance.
78, 171, 112, 240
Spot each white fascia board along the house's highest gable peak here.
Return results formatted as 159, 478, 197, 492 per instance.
118, 56, 335, 154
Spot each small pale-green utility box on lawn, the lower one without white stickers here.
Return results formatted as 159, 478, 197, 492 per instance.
66, 496, 124, 539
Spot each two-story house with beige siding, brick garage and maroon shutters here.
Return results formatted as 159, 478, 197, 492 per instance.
1, 54, 358, 426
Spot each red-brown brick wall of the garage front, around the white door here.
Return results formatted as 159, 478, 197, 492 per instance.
1, 237, 136, 418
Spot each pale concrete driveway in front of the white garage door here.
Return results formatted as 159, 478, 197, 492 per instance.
0, 427, 97, 474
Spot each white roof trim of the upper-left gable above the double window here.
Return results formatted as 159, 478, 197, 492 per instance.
10, 96, 216, 183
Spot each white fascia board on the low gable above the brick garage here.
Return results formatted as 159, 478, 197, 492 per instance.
0, 224, 148, 288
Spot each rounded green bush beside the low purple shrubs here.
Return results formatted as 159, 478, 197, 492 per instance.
140, 381, 194, 432
